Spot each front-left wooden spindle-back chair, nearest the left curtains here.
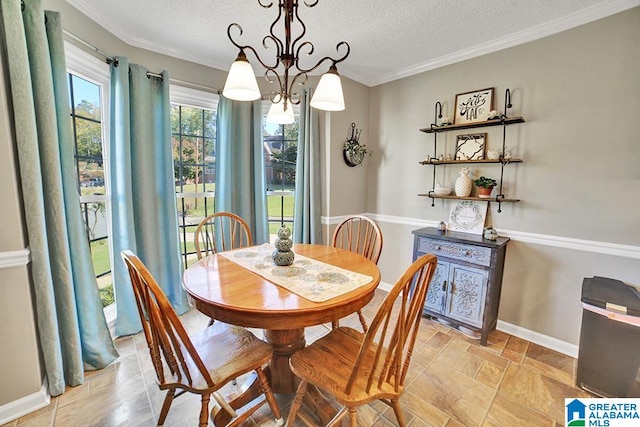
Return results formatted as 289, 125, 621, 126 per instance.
121, 250, 282, 427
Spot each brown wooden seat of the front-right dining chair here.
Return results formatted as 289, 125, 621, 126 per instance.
290, 326, 403, 406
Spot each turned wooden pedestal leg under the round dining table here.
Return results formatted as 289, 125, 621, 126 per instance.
264, 329, 306, 394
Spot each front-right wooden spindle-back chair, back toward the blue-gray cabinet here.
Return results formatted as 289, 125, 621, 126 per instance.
287, 254, 436, 427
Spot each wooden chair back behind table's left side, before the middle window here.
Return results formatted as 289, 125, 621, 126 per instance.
193, 212, 253, 259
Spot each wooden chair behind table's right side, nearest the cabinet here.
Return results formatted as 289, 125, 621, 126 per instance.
331, 215, 382, 332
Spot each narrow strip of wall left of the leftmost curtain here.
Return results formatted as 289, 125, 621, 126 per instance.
0, 32, 43, 408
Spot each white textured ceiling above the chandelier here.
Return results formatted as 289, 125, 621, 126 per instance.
67, 0, 640, 86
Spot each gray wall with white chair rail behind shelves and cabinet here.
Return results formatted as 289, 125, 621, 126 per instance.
367, 8, 640, 344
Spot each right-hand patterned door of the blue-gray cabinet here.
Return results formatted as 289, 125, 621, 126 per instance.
445, 263, 489, 327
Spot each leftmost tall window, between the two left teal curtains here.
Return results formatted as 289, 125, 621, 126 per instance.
65, 43, 115, 308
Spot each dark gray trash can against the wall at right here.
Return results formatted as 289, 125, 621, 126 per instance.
576, 276, 640, 397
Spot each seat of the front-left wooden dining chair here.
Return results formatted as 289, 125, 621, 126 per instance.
161, 322, 272, 392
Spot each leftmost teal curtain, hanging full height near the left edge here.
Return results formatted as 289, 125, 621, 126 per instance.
0, 0, 118, 396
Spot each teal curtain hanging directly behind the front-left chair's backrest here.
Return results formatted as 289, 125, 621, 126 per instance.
109, 57, 189, 336
